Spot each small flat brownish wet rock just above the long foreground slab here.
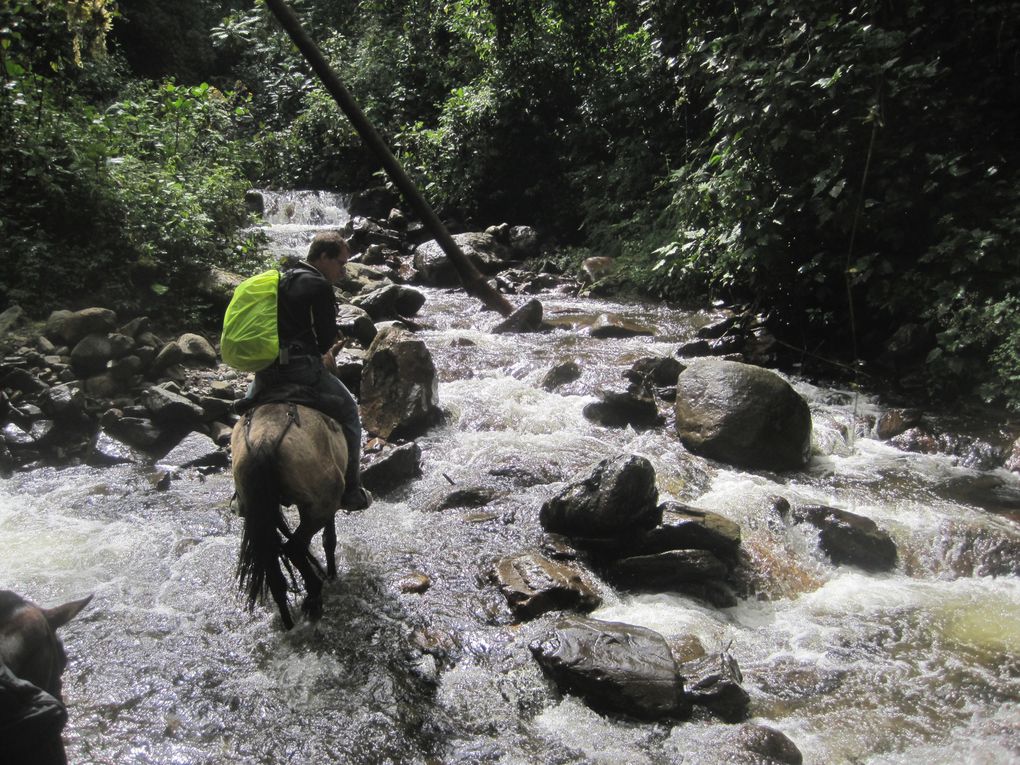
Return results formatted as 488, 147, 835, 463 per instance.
494, 552, 602, 619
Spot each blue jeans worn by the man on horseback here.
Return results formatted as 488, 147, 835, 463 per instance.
245, 356, 361, 492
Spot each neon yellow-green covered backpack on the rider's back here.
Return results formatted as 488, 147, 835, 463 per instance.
219, 268, 279, 372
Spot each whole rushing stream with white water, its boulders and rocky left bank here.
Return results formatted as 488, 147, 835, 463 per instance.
0, 187, 1020, 765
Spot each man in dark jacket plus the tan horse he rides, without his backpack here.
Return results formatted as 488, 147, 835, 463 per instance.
231, 232, 372, 629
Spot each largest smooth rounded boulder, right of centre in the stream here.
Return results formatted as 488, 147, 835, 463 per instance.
675, 359, 811, 470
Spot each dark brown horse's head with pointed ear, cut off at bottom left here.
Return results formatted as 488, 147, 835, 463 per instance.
0, 590, 92, 765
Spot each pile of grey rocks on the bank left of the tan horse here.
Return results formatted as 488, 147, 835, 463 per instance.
0, 307, 237, 470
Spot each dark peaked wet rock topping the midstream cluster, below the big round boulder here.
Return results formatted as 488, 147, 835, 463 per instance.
540, 455, 662, 538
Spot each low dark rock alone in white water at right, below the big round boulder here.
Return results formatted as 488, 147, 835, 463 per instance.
791, 505, 897, 571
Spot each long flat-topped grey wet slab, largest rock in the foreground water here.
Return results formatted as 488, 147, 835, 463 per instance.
529, 616, 691, 719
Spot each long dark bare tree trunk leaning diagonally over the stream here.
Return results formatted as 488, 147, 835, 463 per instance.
265, 0, 514, 316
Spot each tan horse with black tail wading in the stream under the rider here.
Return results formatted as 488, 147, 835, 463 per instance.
231, 403, 348, 629
